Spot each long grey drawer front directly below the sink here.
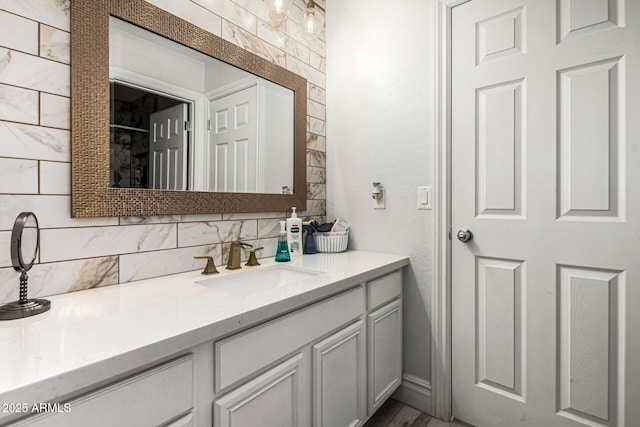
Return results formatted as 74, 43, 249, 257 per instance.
215, 287, 364, 393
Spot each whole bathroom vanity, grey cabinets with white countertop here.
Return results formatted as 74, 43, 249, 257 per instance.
0, 251, 409, 427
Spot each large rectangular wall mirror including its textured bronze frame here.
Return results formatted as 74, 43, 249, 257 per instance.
71, 0, 307, 217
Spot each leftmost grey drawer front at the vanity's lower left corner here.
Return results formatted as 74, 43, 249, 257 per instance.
12, 354, 194, 427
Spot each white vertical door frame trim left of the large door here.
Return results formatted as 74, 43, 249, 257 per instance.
431, 0, 471, 421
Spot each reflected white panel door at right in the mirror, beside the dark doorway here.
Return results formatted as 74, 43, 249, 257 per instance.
209, 86, 258, 193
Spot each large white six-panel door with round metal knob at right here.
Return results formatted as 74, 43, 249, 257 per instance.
451, 0, 640, 427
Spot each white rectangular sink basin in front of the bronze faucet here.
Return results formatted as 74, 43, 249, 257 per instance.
196, 265, 322, 296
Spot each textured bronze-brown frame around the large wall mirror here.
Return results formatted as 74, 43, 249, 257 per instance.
71, 0, 307, 217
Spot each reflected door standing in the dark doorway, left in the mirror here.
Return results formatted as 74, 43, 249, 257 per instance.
149, 104, 188, 190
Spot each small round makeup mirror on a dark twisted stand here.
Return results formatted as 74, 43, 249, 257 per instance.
0, 212, 51, 320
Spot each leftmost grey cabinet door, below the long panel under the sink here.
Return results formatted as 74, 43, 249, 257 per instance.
214, 353, 304, 427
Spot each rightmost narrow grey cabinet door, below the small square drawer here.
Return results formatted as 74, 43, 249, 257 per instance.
367, 300, 402, 414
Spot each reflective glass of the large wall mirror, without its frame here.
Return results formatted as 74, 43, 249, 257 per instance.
109, 17, 294, 194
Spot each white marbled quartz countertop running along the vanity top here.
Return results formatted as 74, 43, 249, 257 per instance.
0, 251, 409, 423
